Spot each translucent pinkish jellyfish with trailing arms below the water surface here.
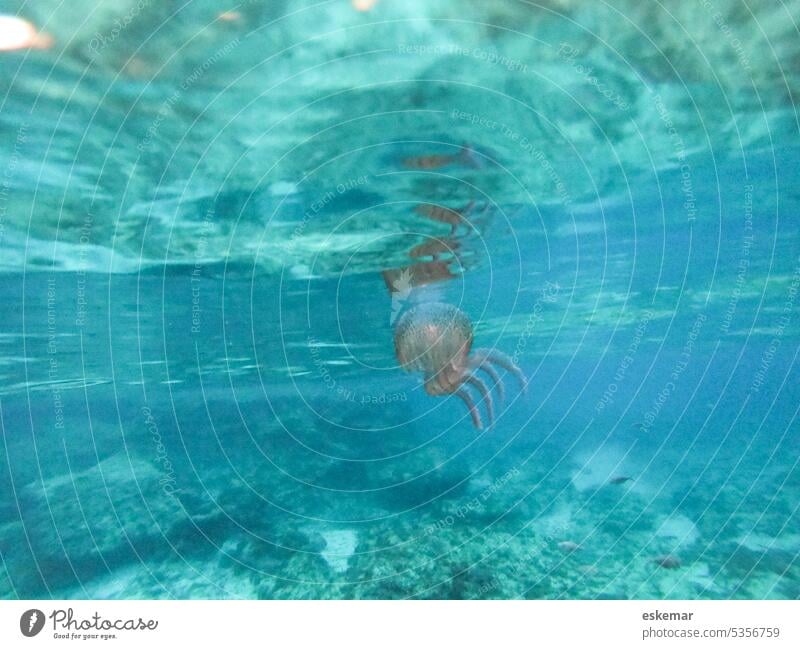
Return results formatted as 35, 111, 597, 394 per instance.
394, 302, 527, 429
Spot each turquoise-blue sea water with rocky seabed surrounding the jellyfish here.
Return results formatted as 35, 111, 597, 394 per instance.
0, 0, 800, 599
